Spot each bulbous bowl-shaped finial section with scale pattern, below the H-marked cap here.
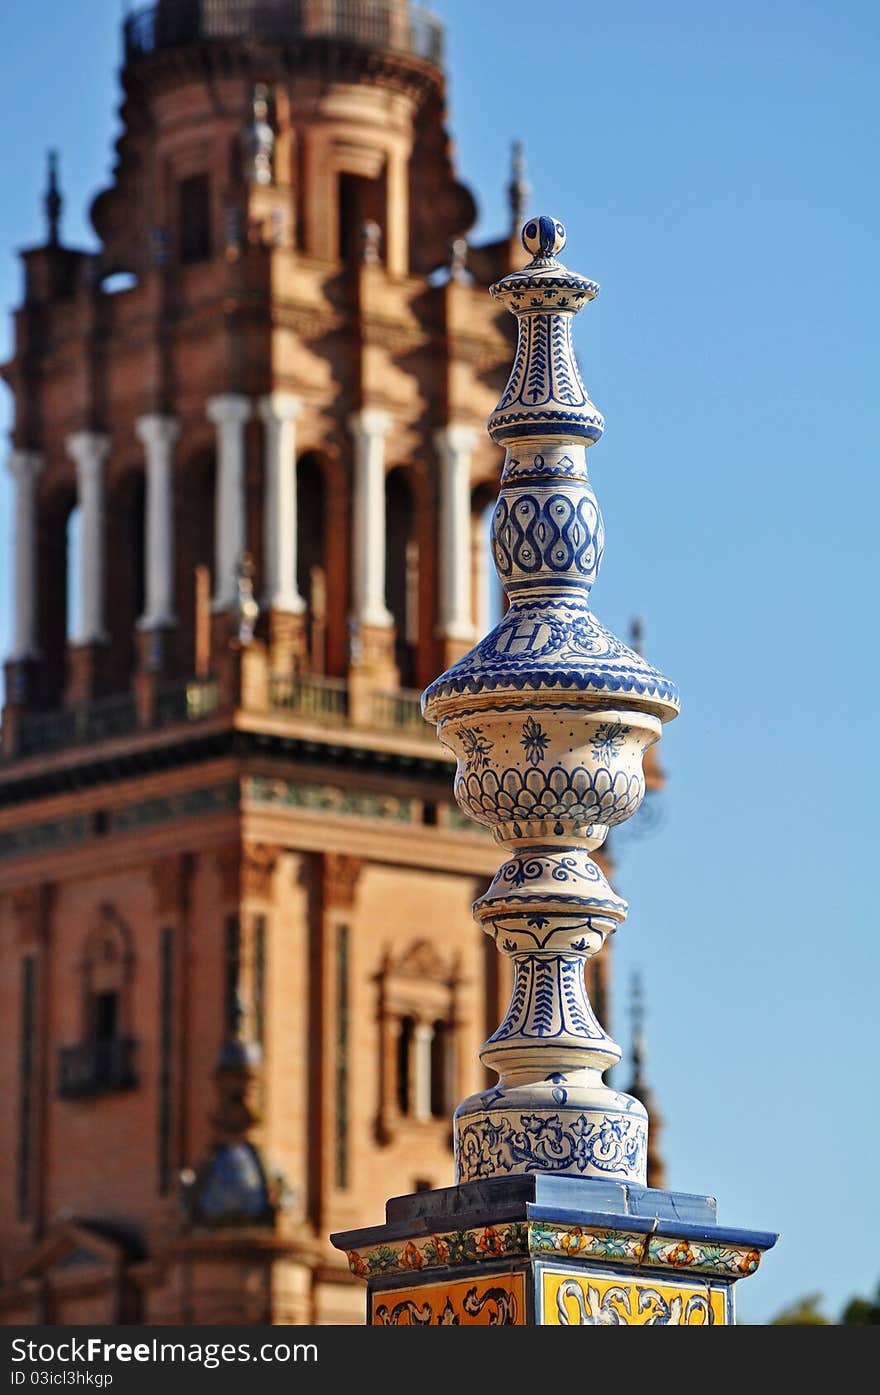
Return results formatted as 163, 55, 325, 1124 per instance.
438, 693, 660, 848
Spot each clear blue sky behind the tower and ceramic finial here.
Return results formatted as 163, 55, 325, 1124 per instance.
0, 0, 880, 1322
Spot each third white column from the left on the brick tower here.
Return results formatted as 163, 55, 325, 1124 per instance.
134, 416, 180, 629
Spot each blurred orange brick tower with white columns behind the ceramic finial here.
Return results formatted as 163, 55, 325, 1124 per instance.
0, 0, 658, 1324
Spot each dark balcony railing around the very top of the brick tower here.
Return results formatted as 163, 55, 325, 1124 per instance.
124, 0, 443, 67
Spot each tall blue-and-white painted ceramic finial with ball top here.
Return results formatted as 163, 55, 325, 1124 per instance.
423, 218, 678, 1184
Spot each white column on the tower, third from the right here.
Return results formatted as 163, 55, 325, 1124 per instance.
259, 392, 305, 612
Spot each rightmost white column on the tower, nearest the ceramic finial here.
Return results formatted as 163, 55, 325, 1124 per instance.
434, 424, 477, 640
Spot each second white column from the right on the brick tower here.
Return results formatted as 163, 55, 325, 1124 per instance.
349, 407, 395, 629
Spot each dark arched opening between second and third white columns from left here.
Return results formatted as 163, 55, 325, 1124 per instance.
107, 469, 146, 692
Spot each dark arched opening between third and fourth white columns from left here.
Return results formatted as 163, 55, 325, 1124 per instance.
174, 449, 216, 677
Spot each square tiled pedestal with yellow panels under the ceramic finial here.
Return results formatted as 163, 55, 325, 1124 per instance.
331, 1175, 777, 1327
